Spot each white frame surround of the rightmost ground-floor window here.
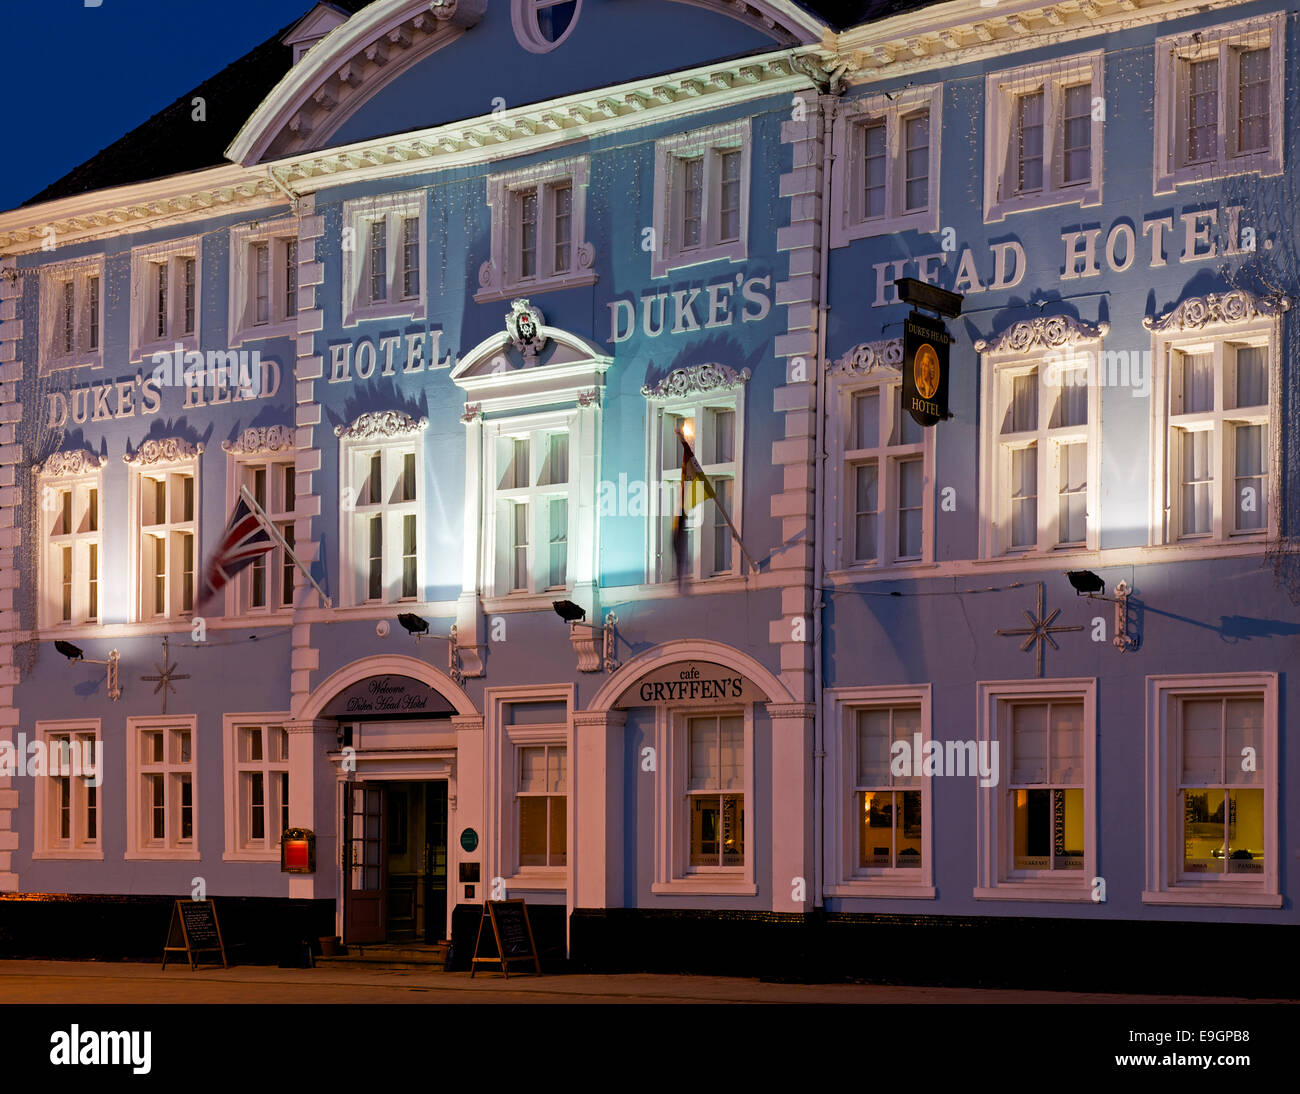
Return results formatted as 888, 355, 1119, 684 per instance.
1141, 672, 1284, 908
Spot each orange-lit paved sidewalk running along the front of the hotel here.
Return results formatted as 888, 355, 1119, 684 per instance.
0, 961, 1284, 1004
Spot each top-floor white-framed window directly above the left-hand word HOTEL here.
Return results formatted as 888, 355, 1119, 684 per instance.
343, 190, 429, 326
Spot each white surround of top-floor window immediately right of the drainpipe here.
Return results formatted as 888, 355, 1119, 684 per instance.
828, 83, 944, 248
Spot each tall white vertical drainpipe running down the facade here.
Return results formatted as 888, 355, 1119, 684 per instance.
813, 65, 848, 908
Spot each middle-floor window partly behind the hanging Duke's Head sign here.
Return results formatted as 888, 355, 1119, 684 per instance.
839, 379, 933, 566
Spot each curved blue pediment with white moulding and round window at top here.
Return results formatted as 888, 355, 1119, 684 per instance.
226, 0, 826, 165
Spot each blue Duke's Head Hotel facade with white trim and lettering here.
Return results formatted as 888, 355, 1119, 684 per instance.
0, 0, 1300, 989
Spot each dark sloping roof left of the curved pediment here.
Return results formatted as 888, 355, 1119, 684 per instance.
22, 0, 372, 205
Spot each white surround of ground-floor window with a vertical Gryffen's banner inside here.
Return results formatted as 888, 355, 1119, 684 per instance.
974, 677, 1099, 902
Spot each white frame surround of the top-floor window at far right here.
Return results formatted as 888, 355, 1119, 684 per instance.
1152, 12, 1287, 195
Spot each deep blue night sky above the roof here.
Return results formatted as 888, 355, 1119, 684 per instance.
0, 0, 313, 210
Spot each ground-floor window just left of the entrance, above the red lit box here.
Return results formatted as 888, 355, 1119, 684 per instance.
225, 716, 289, 859
